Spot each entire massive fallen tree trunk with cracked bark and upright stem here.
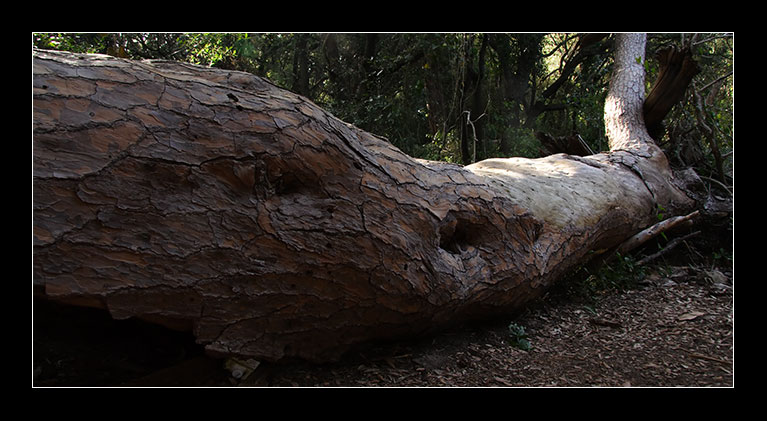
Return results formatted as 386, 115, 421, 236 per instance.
33, 35, 693, 361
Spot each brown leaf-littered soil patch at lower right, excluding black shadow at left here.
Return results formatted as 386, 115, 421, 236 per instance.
249, 268, 734, 387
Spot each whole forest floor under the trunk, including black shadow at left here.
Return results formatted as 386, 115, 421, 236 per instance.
32, 246, 734, 388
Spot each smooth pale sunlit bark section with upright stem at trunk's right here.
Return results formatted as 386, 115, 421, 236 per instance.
466, 34, 691, 256
